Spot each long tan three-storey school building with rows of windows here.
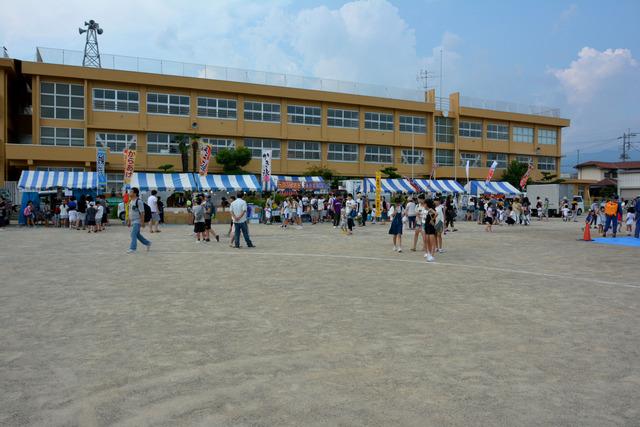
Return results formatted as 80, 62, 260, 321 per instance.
0, 49, 569, 193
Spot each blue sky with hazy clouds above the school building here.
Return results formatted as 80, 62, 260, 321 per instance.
0, 0, 640, 170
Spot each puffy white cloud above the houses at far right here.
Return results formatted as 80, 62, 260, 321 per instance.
549, 47, 638, 105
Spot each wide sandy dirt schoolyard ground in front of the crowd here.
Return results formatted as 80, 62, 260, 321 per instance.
0, 221, 640, 427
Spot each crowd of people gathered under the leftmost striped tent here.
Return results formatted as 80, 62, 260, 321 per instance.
22, 195, 110, 233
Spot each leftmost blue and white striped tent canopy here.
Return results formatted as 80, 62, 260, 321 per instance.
18, 171, 98, 191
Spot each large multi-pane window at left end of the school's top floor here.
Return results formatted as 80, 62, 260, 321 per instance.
40, 82, 84, 120
